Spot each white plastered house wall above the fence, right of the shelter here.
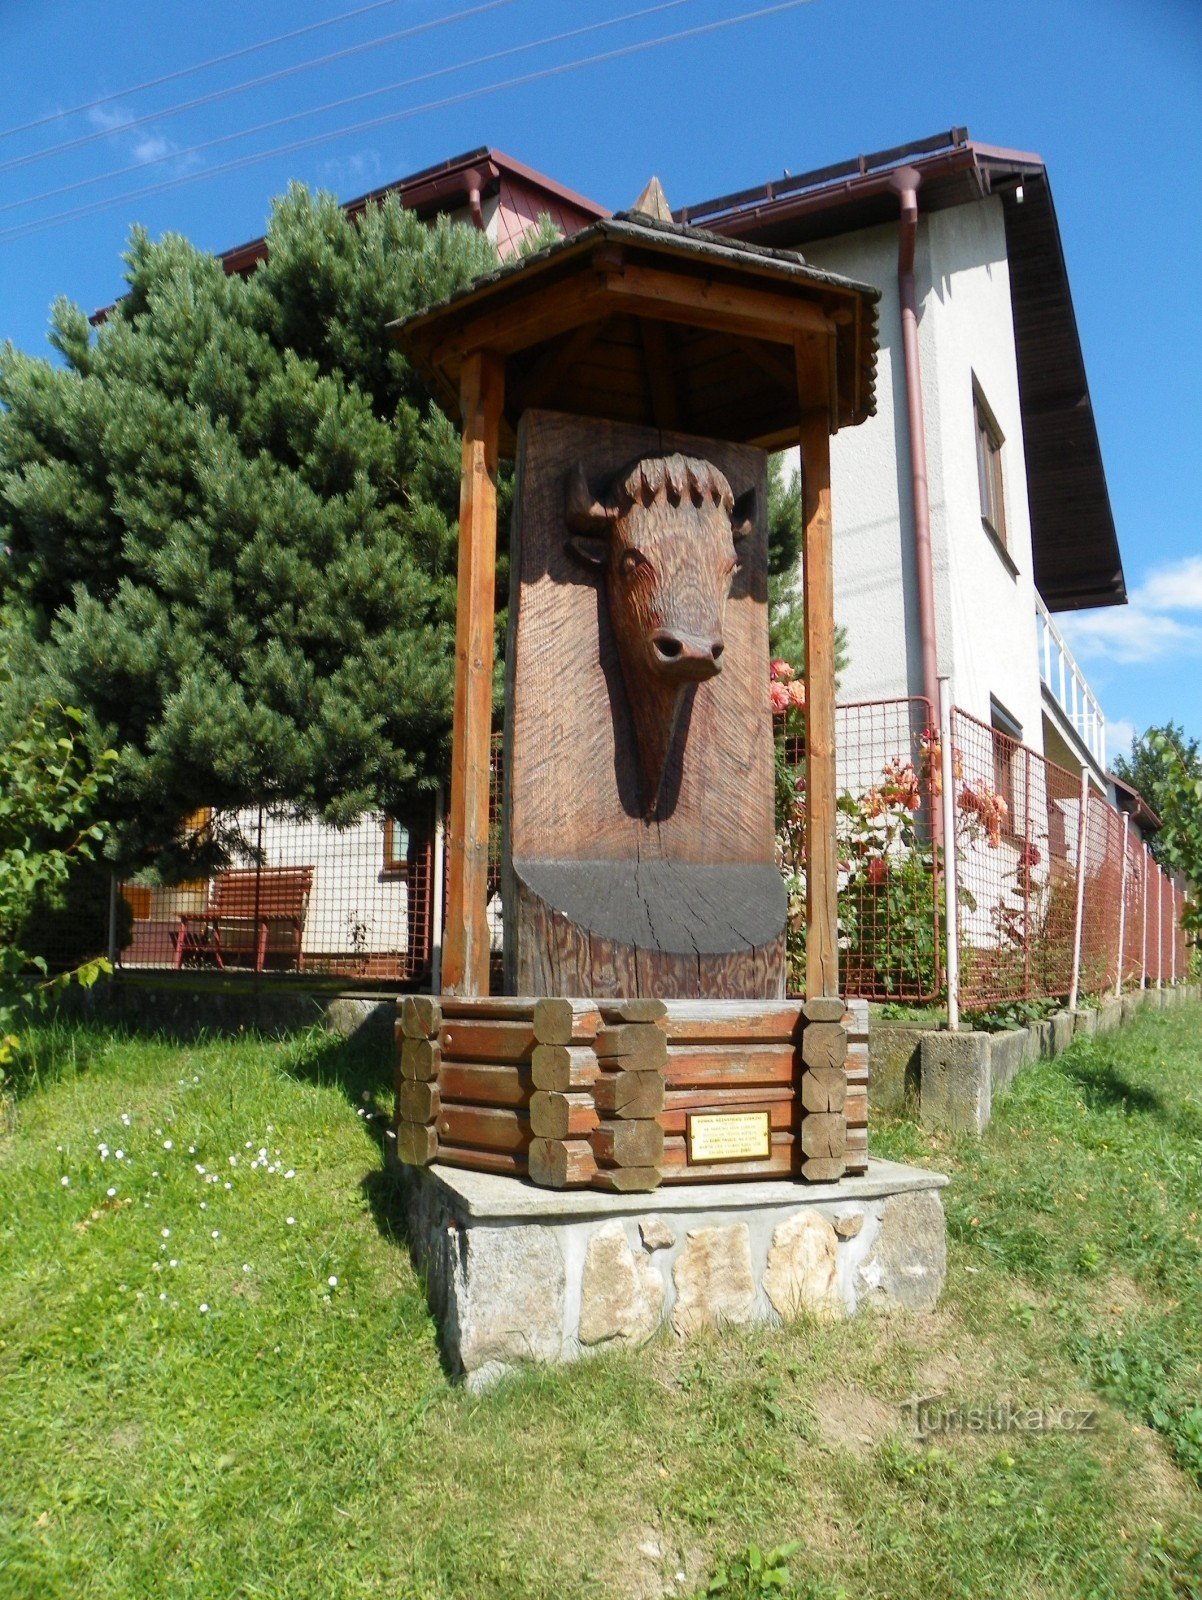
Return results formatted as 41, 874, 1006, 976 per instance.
791, 198, 1042, 747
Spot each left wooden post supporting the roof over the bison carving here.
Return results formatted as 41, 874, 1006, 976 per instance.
442, 350, 504, 995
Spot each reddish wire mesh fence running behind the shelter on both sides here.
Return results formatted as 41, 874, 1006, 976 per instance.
29, 696, 1189, 1010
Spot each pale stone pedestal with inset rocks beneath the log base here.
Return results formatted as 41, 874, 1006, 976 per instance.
400, 1162, 948, 1387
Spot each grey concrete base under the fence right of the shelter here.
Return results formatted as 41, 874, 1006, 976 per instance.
896, 984, 1202, 1133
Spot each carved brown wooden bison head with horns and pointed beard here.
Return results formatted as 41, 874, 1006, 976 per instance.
568, 454, 755, 816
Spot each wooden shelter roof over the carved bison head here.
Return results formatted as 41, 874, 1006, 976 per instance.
389, 211, 879, 450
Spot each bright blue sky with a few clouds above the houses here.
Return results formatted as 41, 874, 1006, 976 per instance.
0, 0, 1202, 761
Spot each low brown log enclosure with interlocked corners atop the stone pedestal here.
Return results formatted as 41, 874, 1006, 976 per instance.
397, 995, 867, 1192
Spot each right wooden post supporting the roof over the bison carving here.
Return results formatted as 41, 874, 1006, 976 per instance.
799, 400, 839, 1000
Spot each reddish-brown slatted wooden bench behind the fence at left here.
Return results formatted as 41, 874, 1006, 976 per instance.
174, 867, 314, 973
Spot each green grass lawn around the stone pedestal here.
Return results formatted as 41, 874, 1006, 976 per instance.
0, 1008, 1202, 1600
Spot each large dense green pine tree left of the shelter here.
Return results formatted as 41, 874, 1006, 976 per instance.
0, 187, 506, 861
